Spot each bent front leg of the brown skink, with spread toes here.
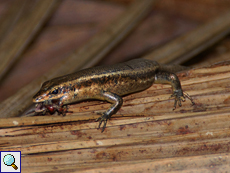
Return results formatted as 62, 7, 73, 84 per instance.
96, 91, 123, 132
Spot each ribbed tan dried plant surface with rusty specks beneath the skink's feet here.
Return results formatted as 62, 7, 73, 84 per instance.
0, 62, 230, 172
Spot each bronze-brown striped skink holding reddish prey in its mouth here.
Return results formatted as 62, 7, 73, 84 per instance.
33, 59, 194, 132
